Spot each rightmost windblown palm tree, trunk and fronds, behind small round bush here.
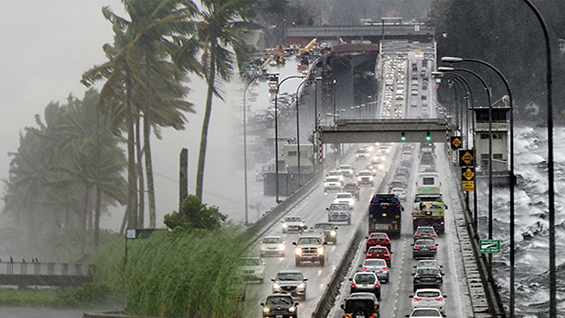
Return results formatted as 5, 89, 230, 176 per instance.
196, 0, 259, 200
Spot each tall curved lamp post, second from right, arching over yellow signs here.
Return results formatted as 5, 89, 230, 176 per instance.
441, 56, 516, 318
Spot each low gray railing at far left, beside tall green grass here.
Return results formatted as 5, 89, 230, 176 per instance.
0, 262, 96, 276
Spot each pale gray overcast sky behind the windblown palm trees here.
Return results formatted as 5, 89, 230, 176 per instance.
0, 0, 256, 229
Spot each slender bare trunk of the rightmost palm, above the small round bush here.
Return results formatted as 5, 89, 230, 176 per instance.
196, 56, 216, 201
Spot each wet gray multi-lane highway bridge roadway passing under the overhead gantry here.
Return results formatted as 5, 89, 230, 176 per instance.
238, 34, 505, 318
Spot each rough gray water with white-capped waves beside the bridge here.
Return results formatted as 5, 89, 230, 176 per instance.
478, 127, 565, 318
